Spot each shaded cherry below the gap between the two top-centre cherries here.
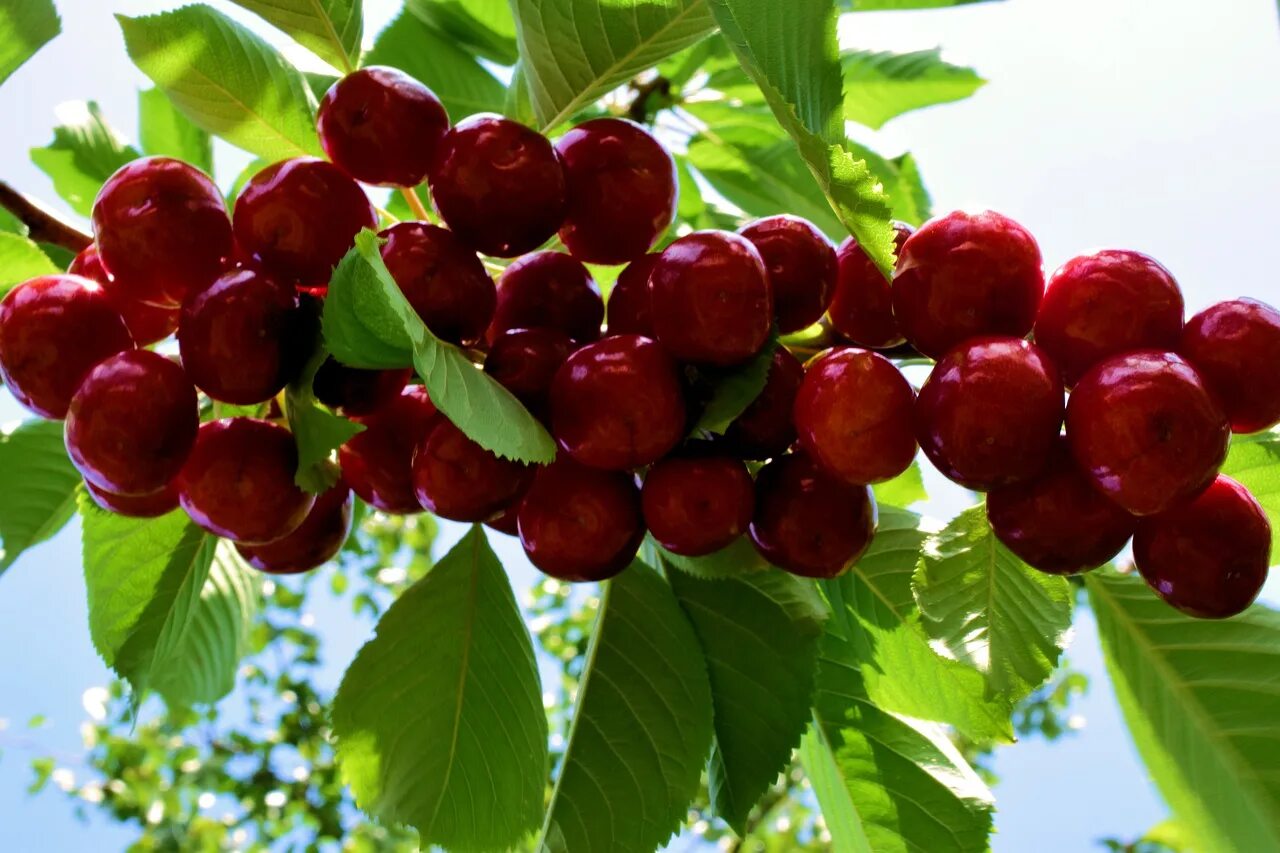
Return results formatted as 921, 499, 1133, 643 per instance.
489, 252, 604, 343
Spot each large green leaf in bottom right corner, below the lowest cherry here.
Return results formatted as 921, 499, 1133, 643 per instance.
1085, 569, 1280, 850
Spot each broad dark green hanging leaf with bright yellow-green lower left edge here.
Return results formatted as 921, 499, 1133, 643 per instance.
333, 526, 548, 850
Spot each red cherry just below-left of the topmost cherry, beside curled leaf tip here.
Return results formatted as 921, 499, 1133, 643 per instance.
232, 158, 378, 287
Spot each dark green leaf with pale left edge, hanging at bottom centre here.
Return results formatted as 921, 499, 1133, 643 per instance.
543, 560, 712, 853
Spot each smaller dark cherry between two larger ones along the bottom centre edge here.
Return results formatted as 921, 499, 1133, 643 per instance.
640, 456, 755, 557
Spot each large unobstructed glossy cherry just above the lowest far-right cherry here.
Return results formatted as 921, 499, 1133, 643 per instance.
1066, 350, 1231, 515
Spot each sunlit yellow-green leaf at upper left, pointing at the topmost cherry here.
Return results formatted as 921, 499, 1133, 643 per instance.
116, 4, 321, 160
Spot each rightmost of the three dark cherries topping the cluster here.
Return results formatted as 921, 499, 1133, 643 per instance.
556, 118, 677, 265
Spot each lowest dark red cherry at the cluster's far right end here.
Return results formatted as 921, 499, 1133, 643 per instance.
1133, 475, 1271, 619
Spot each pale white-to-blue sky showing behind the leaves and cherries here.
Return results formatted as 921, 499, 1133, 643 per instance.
0, 0, 1280, 853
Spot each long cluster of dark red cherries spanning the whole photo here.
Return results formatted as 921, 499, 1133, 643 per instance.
0, 68, 1280, 617
